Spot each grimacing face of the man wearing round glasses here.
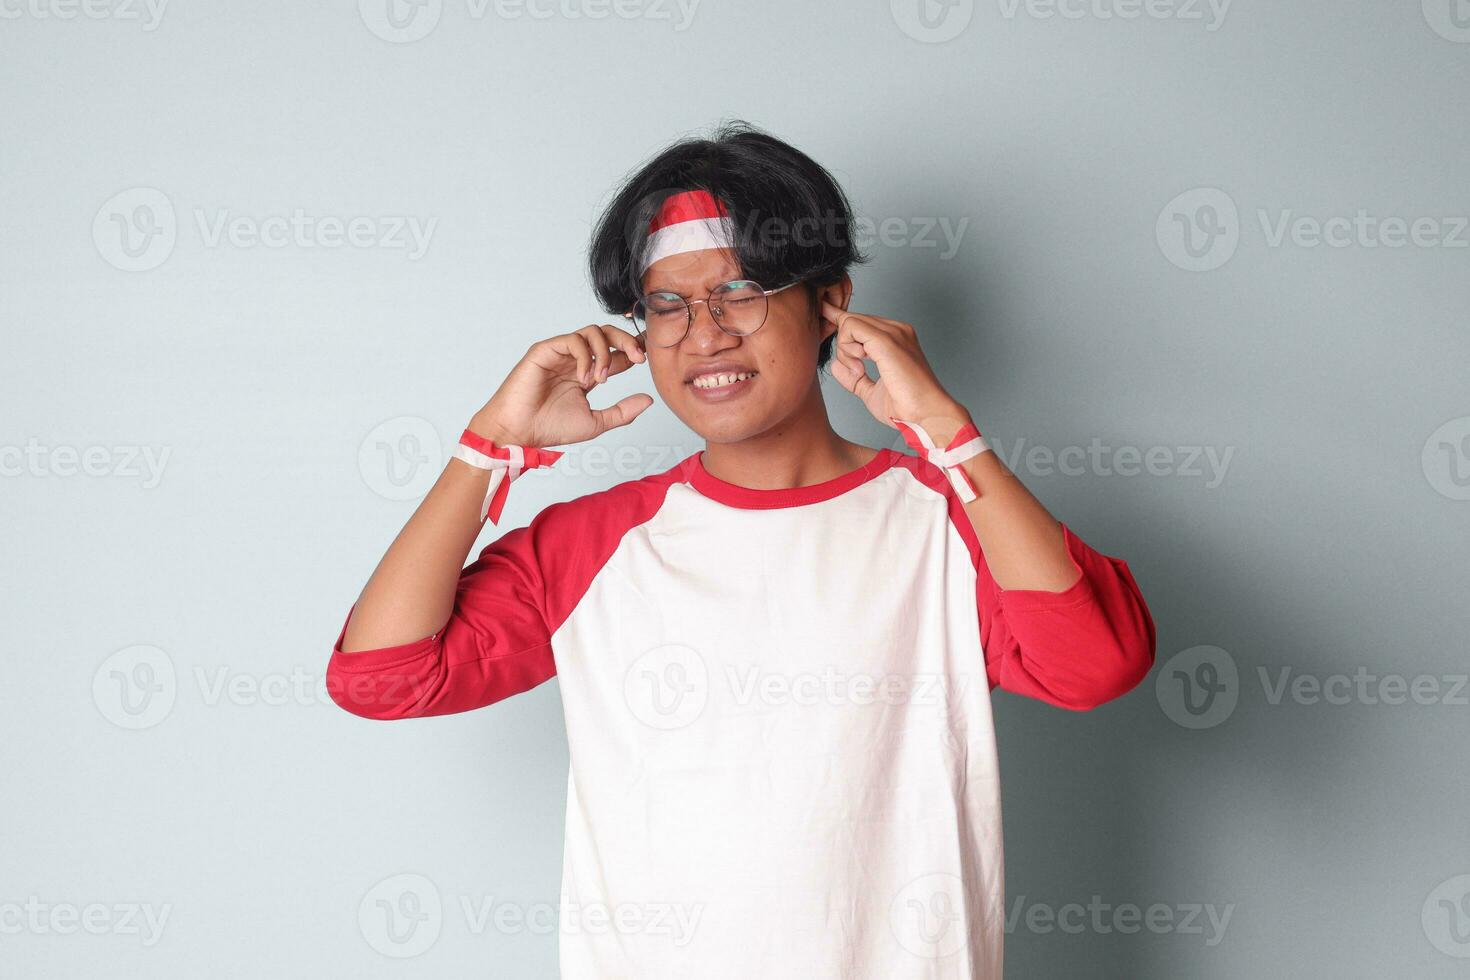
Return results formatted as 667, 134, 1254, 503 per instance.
642, 248, 833, 442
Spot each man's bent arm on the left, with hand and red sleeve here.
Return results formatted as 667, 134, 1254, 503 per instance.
326, 323, 653, 718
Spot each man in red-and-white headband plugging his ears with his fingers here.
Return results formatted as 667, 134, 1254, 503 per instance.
328, 126, 1154, 980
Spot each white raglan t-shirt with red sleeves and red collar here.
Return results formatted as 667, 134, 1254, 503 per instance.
328, 448, 1155, 980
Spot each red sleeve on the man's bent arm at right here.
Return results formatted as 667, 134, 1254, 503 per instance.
960, 513, 1155, 711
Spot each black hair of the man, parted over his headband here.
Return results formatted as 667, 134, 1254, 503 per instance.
588, 119, 867, 370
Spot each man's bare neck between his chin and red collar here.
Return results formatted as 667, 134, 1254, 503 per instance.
701, 379, 878, 489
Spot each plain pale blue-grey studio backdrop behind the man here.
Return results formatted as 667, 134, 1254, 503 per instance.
0, 0, 1470, 980
